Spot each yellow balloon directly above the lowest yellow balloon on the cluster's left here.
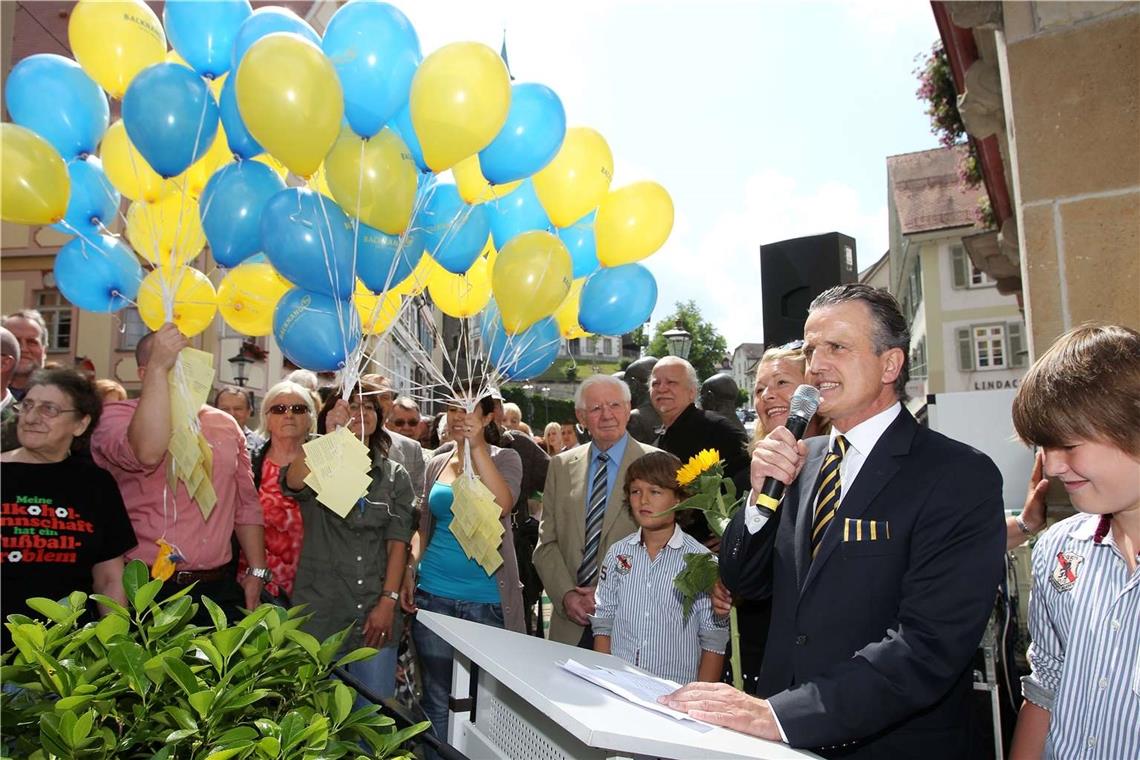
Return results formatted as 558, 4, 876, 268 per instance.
127, 193, 206, 269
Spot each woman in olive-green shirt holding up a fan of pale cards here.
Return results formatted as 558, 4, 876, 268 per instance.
282, 383, 415, 705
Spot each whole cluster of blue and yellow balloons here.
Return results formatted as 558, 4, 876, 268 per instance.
0, 0, 673, 378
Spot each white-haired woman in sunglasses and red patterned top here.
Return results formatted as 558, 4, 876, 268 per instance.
238, 381, 317, 605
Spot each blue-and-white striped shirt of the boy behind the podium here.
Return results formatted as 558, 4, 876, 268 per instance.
589, 525, 728, 684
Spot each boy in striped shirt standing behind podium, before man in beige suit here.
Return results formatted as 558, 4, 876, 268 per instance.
591, 451, 728, 685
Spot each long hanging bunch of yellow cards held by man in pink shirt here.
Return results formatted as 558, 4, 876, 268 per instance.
166, 348, 218, 520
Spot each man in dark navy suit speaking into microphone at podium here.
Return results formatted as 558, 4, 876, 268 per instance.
663, 284, 1005, 760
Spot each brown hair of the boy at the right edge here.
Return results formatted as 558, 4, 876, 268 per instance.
1013, 324, 1140, 457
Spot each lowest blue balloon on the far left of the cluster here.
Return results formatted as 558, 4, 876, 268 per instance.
55, 235, 143, 312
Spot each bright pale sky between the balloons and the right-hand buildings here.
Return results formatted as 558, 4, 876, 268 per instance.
396, 0, 937, 350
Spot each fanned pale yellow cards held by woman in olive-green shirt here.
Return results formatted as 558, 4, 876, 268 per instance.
302, 427, 372, 517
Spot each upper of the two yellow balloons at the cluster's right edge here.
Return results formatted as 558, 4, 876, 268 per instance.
535, 126, 613, 227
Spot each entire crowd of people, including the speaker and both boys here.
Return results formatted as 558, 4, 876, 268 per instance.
0, 285, 1140, 758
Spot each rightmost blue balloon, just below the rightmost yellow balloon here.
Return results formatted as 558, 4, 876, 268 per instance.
578, 264, 657, 335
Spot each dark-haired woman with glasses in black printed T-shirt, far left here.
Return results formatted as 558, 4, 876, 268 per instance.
0, 369, 137, 651
